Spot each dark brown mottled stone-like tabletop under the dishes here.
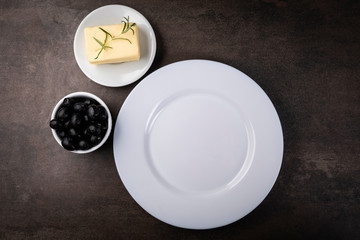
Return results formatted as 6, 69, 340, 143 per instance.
0, 0, 360, 239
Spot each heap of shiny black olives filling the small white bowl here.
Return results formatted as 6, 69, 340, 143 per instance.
50, 97, 108, 151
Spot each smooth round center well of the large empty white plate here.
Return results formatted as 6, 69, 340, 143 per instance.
145, 92, 249, 192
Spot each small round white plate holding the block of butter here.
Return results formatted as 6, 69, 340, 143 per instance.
74, 5, 156, 87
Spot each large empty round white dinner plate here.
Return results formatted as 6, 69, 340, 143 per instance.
114, 60, 283, 229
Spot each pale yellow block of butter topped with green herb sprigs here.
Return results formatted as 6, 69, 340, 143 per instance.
84, 23, 140, 64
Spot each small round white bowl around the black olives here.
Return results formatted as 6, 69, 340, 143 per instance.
50, 92, 112, 154
